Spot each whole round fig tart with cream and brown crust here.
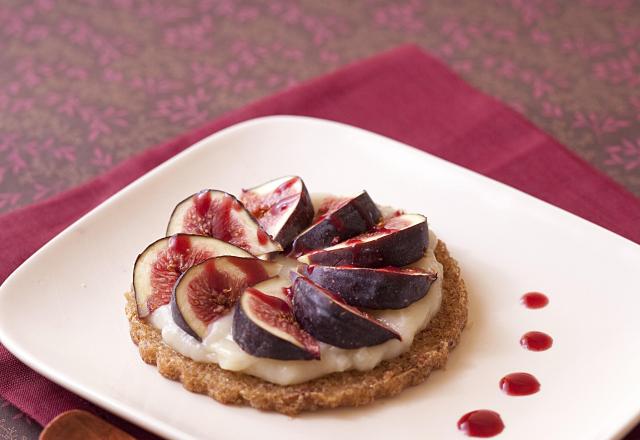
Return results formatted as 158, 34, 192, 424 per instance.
125, 176, 467, 415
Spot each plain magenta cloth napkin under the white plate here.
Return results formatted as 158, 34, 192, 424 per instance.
0, 46, 640, 435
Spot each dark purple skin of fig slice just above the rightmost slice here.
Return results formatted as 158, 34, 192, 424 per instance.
298, 215, 429, 268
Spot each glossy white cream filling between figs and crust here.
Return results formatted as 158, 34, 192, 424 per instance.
149, 199, 443, 385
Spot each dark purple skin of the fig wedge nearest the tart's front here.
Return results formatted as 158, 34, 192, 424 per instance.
232, 290, 320, 361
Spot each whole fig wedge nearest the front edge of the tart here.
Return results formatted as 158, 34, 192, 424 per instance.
232, 285, 320, 360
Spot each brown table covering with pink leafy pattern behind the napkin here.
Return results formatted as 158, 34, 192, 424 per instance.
0, 0, 640, 439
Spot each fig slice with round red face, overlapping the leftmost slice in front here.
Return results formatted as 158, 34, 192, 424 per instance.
171, 256, 282, 341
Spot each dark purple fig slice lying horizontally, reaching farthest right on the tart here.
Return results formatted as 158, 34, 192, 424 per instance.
298, 265, 438, 309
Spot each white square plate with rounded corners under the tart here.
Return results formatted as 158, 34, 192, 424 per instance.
0, 116, 640, 440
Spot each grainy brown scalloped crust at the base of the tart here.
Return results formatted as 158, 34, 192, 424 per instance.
126, 241, 467, 416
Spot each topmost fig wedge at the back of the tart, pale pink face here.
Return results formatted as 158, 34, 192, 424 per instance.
240, 176, 313, 249
